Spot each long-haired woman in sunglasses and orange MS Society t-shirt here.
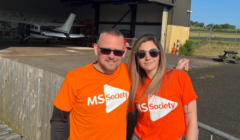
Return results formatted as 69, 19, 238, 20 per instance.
128, 34, 198, 140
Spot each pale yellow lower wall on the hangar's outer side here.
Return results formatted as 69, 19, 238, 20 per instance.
165, 25, 190, 53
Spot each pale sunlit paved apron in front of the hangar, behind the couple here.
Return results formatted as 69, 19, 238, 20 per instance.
0, 40, 220, 77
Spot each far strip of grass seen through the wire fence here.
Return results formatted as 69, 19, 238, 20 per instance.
189, 31, 240, 38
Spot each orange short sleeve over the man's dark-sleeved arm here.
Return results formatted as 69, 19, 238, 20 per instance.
53, 74, 75, 112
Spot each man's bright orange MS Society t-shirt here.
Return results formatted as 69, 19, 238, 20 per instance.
53, 63, 131, 140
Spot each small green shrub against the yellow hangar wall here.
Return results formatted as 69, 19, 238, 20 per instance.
179, 40, 194, 56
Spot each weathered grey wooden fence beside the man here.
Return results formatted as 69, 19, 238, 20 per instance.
0, 57, 64, 140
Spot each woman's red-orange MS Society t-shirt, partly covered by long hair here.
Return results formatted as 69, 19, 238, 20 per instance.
131, 70, 197, 140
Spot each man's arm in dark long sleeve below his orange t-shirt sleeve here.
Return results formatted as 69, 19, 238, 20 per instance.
50, 106, 70, 140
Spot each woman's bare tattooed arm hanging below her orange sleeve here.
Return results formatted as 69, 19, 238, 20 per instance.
184, 100, 198, 140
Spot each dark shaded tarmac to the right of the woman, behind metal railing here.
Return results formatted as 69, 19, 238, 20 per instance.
187, 63, 240, 140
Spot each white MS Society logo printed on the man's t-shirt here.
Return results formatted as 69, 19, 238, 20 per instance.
87, 85, 129, 113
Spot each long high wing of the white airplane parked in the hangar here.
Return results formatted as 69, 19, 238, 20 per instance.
0, 17, 85, 26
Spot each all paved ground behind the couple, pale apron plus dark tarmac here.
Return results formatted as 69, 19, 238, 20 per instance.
0, 40, 240, 140
